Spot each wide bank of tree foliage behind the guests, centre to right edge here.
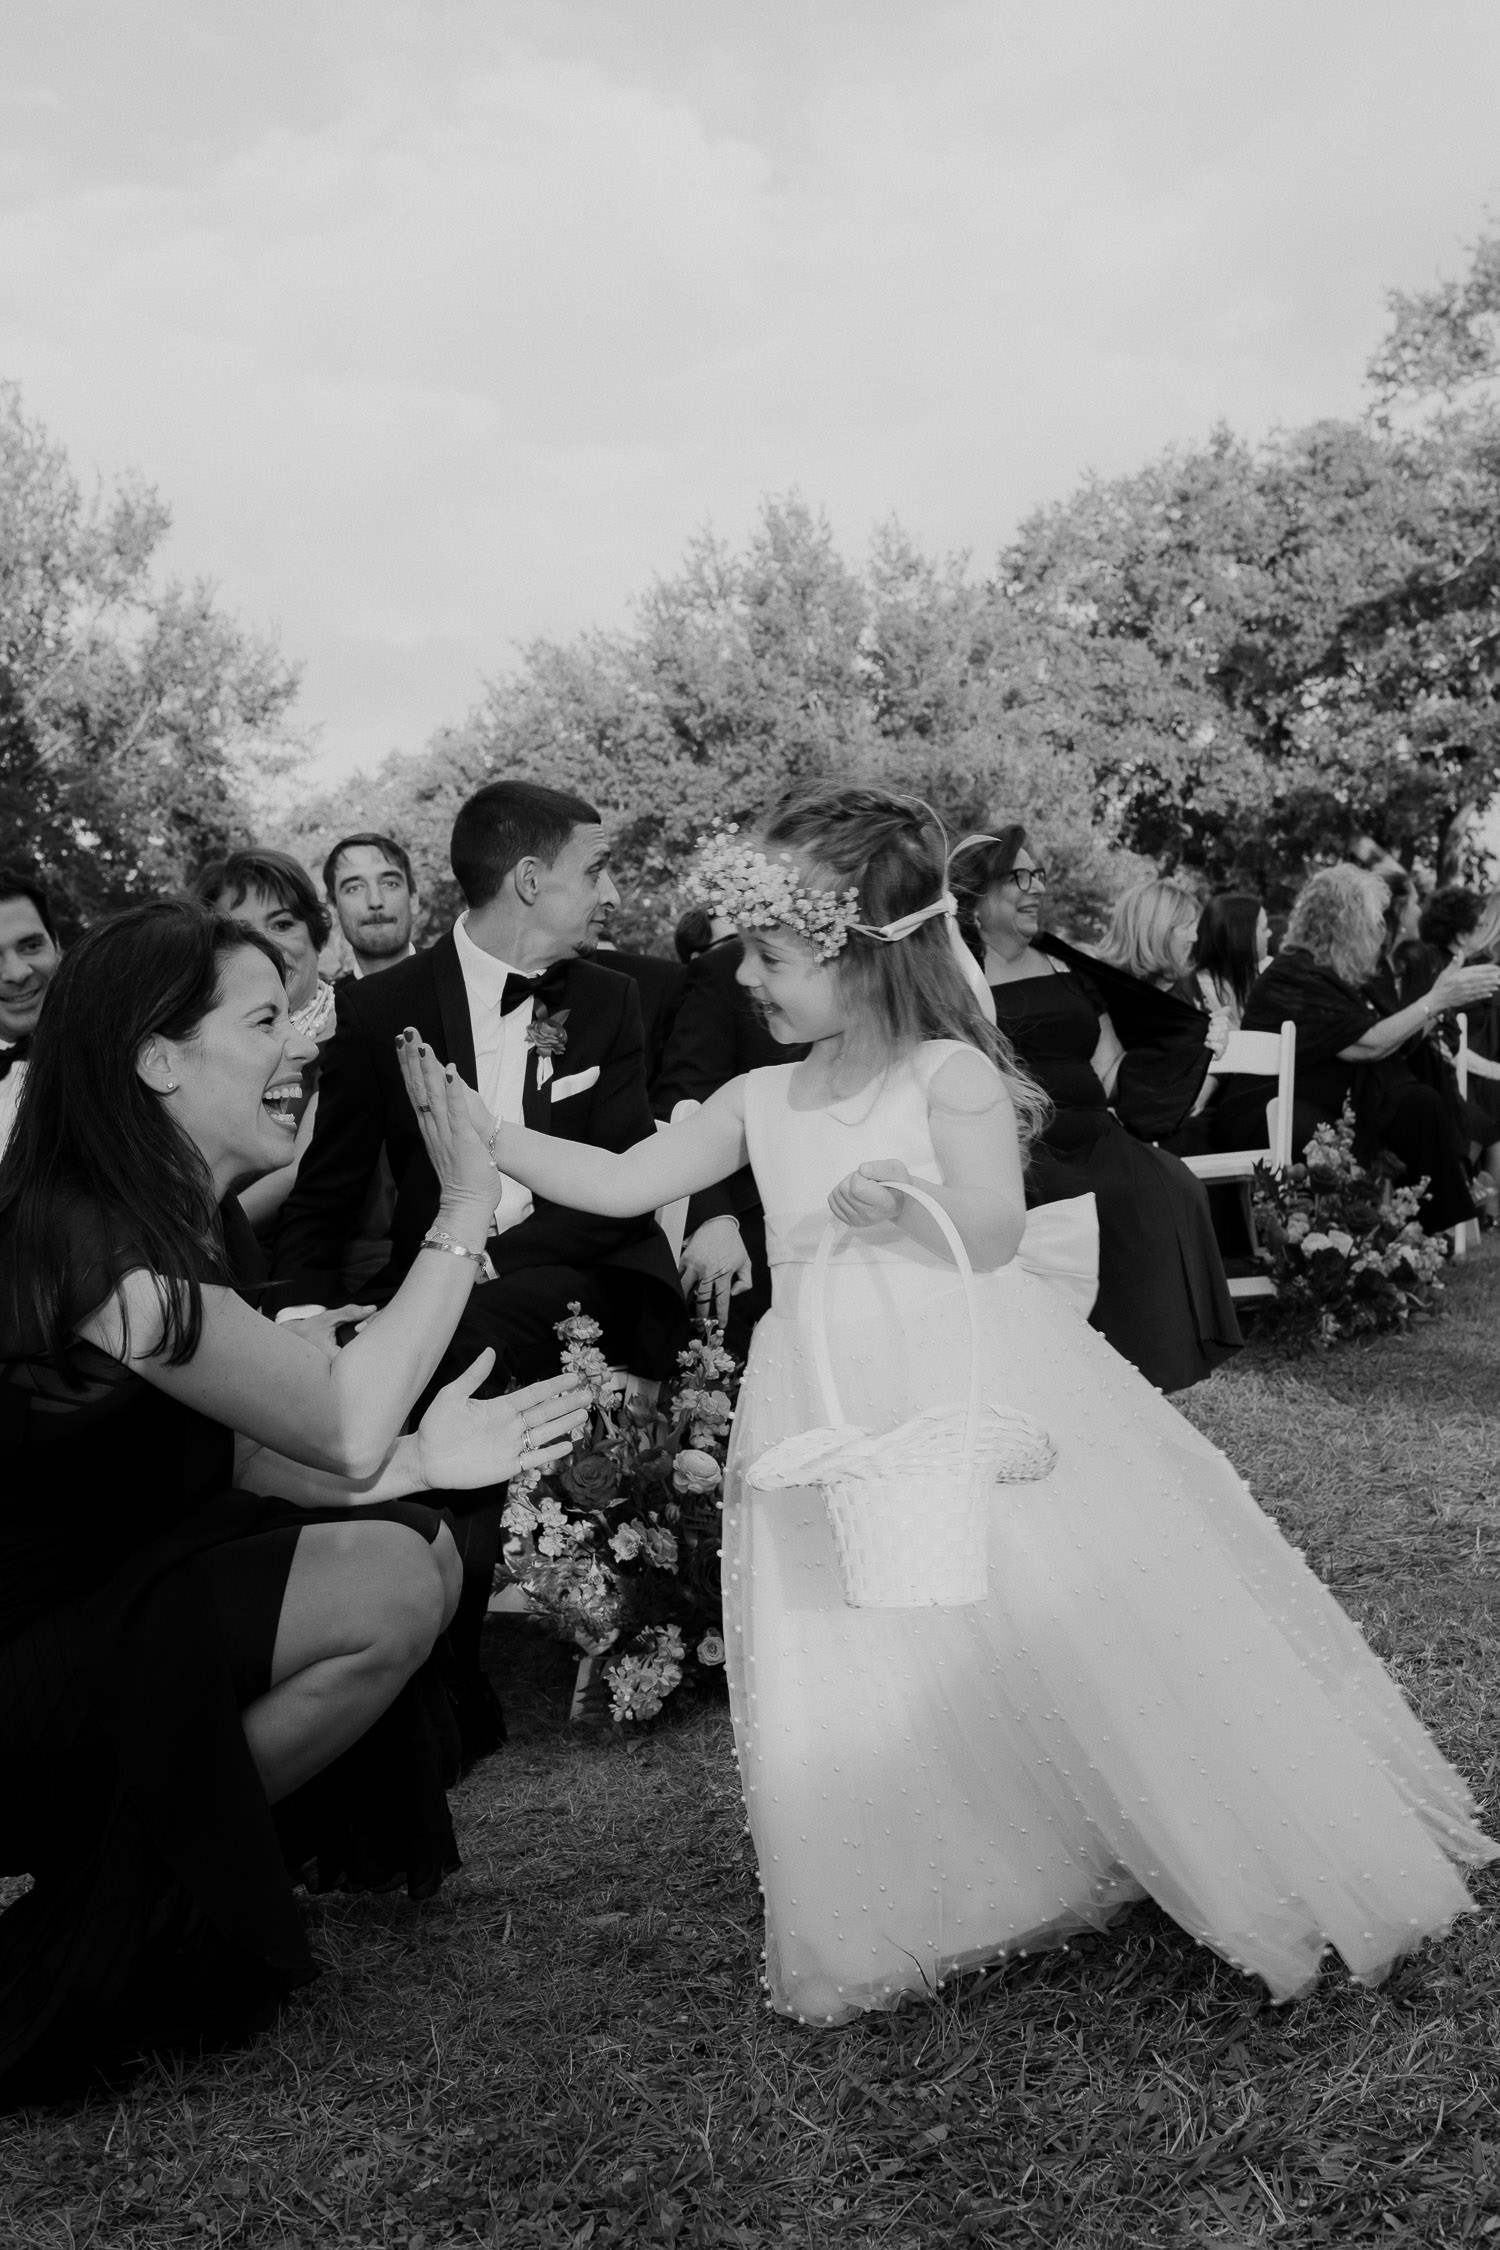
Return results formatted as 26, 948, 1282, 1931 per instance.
296, 236, 1500, 941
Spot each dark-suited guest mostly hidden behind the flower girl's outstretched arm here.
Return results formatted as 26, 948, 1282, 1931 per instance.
652, 925, 807, 1359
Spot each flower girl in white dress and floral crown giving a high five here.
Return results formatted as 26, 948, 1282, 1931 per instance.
404, 788, 1498, 2023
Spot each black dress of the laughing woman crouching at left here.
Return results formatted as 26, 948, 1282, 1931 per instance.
0, 1206, 459, 2106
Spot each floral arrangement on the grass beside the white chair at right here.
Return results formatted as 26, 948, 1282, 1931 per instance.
1253, 1109, 1444, 1352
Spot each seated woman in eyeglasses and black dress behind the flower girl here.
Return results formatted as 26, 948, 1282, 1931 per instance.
951, 821, 1241, 1391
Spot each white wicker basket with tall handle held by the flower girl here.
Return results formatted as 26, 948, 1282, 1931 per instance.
749, 1179, 1057, 1609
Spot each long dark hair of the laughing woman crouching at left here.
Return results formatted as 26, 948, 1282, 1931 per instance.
0, 898, 286, 1366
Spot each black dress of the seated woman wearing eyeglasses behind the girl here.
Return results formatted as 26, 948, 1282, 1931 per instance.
990, 970, 1244, 1391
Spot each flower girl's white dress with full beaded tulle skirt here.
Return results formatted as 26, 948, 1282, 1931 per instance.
724, 1042, 1500, 2023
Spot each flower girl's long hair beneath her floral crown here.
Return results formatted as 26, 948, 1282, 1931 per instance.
760, 783, 1050, 1150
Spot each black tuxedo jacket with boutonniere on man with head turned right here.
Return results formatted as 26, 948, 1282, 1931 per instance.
265, 936, 681, 1319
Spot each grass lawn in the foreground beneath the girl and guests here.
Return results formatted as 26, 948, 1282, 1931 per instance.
0, 1244, 1500, 2250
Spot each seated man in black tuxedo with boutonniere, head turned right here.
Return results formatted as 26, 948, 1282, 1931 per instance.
265, 781, 686, 1757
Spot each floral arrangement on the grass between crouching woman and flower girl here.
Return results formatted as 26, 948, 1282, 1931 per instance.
501, 1305, 740, 1721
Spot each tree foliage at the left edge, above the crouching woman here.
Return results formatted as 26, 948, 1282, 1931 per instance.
0, 385, 297, 923
